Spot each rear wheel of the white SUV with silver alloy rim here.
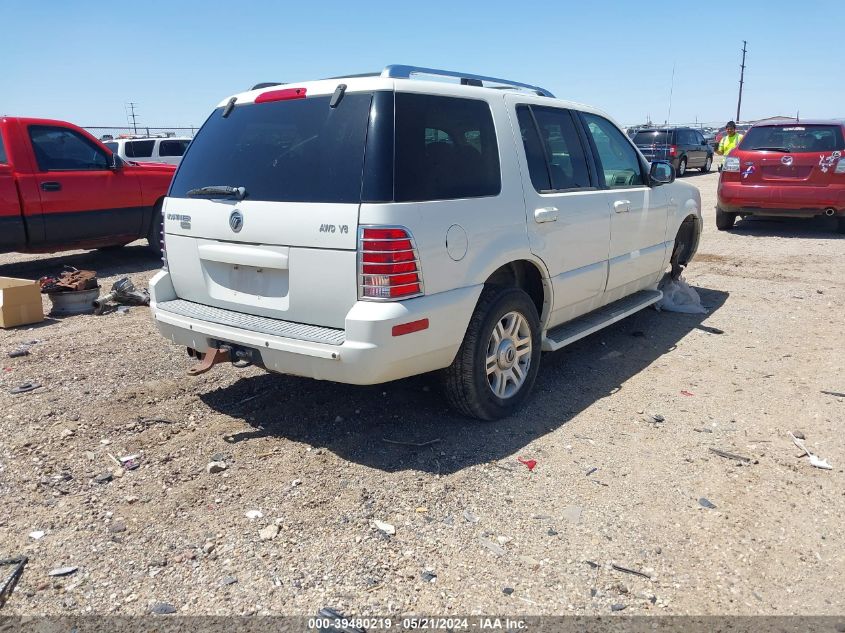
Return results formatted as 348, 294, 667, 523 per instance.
444, 288, 540, 420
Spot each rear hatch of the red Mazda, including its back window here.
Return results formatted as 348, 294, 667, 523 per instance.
731, 123, 845, 187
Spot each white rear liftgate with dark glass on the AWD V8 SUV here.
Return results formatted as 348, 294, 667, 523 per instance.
164, 86, 373, 328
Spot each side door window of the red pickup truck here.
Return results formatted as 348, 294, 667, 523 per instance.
29, 125, 109, 171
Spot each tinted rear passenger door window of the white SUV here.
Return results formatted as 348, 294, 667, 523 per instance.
517, 106, 590, 191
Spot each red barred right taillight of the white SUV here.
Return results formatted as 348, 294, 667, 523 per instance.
358, 227, 423, 301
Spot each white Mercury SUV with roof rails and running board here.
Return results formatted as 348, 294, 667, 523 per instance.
151, 66, 702, 419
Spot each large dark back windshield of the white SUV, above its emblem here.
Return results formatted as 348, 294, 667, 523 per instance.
170, 93, 372, 202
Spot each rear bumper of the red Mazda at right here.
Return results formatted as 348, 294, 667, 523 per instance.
718, 182, 845, 217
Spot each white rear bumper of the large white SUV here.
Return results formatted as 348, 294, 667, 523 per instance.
150, 271, 483, 385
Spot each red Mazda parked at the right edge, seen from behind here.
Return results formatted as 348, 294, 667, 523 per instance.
716, 121, 845, 233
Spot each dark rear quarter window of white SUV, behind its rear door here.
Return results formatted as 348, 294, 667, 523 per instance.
394, 92, 501, 202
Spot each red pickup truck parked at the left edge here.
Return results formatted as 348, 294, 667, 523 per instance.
0, 117, 176, 253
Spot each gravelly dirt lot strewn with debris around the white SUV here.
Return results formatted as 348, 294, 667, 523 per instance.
0, 173, 845, 615
